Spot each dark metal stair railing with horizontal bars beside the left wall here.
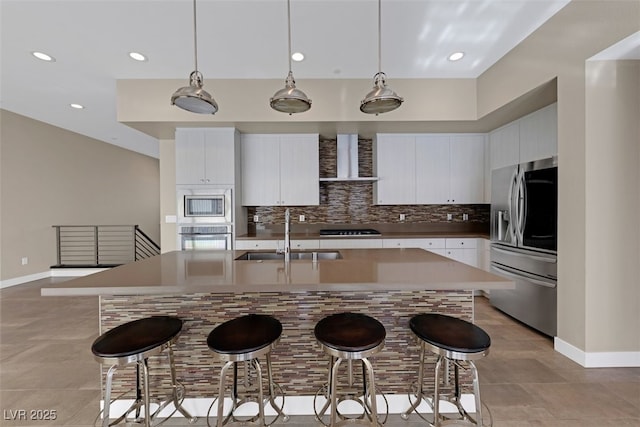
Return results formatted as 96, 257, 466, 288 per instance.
53, 225, 160, 268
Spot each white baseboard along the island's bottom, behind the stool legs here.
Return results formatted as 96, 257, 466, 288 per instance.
100, 394, 475, 418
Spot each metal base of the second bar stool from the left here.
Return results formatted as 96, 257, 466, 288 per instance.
207, 354, 289, 427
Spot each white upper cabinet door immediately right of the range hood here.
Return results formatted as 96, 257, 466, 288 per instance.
374, 135, 416, 205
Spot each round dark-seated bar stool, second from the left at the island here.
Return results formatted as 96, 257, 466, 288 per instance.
207, 314, 289, 427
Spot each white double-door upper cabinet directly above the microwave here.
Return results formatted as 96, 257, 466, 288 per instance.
176, 128, 239, 185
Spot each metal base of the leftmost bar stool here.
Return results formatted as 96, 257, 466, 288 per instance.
94, 341, 197, 427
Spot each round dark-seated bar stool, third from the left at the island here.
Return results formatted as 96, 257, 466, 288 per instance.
313, 313, 389, 427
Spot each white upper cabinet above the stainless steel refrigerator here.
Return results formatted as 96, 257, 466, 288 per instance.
489, 103, 558, 170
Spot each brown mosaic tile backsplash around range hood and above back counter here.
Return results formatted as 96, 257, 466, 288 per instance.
248, 139, 490, 225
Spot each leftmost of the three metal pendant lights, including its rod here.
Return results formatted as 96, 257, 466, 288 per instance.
171, 0, 218, 114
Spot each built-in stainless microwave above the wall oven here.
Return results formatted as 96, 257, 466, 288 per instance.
178, 188, 232, 224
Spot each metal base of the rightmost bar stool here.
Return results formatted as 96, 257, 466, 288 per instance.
400, 339, 493, 427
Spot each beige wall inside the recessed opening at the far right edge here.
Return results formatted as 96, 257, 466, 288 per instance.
585, 61, 640, 352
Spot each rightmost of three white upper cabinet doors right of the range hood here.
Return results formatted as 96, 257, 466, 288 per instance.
448, 135, 485, 204
